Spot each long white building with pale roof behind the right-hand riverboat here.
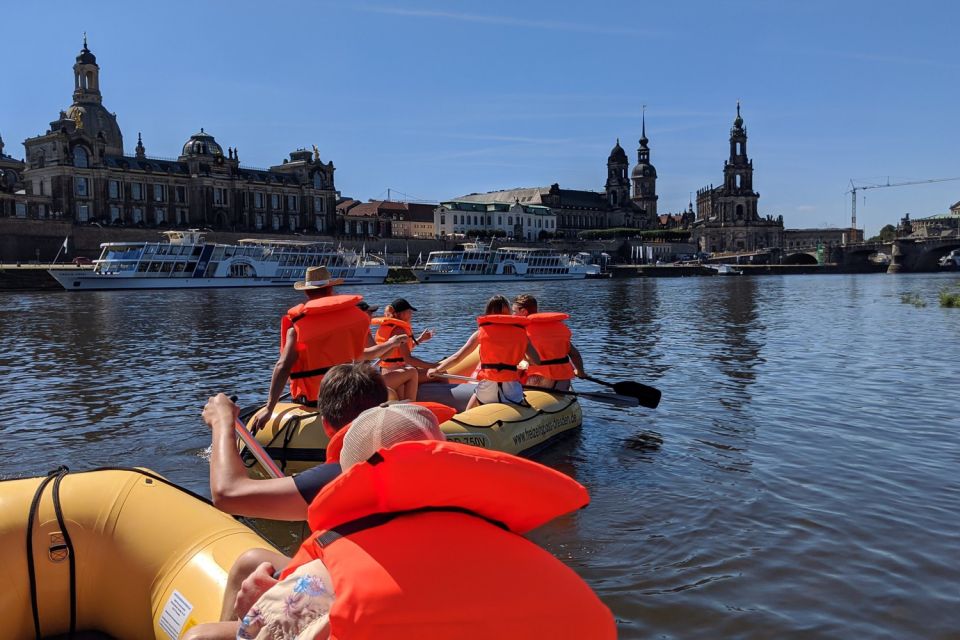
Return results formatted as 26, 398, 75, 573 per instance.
433, 200, 557, 241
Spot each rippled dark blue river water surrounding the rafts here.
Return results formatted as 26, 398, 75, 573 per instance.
0, 274, 960, 638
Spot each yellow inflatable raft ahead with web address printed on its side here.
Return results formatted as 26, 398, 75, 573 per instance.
244, 355, 583, 476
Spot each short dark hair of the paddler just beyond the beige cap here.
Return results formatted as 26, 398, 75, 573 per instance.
317, 362, 387, 429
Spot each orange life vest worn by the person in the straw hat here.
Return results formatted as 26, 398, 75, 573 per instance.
280, 295, 370, 402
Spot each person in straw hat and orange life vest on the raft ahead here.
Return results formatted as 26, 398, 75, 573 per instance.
252, 267, 407, 433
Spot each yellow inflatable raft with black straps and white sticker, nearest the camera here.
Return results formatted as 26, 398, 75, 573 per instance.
0, 469, 273, 640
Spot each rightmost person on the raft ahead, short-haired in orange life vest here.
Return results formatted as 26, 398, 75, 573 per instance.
512, 293, 586, 391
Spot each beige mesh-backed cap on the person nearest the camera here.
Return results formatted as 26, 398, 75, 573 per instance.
340, 404, 446, 471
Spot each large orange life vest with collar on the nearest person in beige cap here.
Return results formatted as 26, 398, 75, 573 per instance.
283, 441, 616, 640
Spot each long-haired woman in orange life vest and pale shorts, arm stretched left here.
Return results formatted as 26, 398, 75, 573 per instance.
428, 296, 539, 410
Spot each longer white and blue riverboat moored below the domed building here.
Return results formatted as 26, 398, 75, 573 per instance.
49, 229, 389, 291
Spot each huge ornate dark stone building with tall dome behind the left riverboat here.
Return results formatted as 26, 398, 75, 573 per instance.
8, 39, 337, 232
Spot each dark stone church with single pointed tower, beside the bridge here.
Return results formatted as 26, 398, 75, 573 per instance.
692, 102, 783, 253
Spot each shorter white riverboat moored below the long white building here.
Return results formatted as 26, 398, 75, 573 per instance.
413, 242, 600, 282
